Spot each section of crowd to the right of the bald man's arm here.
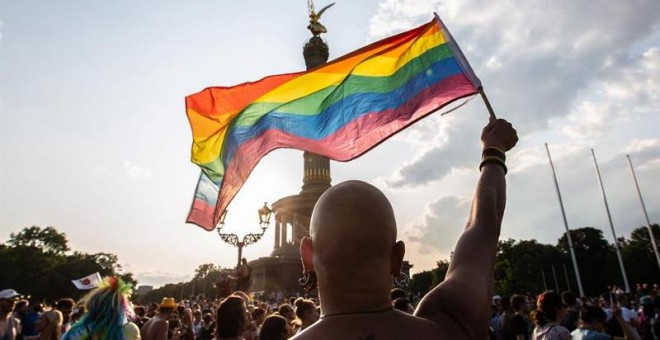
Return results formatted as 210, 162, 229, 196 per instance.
490, 284, 660, 340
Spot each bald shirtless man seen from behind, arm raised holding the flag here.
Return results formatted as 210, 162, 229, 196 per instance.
295, 119, 518, 340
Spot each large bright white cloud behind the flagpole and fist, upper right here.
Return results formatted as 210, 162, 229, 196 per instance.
370, 0, 660, 188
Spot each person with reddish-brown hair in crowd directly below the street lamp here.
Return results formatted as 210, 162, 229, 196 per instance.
215, 295, 249, 340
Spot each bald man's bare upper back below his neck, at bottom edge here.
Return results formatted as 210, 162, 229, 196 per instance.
293, 310, 460, 340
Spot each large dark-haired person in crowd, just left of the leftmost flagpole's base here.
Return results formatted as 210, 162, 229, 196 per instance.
532, 291, 571, 340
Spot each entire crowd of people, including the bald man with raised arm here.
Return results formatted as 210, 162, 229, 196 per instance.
0, 118, 659, 340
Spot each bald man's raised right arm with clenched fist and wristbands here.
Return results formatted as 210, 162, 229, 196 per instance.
415, 119, 518, 339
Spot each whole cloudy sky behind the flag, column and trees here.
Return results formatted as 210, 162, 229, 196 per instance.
0, 0, 660, 289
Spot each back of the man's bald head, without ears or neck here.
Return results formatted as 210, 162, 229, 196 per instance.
310, 181, 396, 266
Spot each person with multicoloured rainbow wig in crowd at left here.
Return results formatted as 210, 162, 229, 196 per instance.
62, 276, 140, 340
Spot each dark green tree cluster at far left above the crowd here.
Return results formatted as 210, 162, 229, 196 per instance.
0, 226, 137, 301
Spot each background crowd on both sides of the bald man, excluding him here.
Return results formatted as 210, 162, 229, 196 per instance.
5, 277, 660, 340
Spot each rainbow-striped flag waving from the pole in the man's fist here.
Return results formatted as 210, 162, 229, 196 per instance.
186, 15, 481, 230
